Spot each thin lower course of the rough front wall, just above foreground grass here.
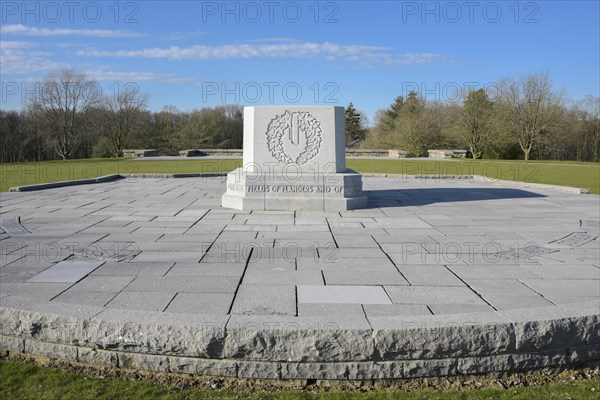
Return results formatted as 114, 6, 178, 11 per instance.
0, 335, 600, 380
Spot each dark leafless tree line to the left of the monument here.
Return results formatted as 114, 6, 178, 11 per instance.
0, 69, 243, 162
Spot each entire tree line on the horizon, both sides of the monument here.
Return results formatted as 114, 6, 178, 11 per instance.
0, 69, 600, 162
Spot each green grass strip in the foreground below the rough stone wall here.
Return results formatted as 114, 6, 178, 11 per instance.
0, 361, 600, 400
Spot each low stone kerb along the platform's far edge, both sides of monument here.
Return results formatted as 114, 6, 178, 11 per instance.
8, 172, 591, 194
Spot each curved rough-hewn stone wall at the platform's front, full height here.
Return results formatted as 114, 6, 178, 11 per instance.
0, 297, 600, 380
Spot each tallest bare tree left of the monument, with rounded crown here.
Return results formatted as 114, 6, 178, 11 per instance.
29, 69, 102, 159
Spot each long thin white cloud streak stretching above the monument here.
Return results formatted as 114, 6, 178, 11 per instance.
76, 40, 446, 66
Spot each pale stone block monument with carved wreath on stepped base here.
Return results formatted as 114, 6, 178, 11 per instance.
221, 106, 367, 211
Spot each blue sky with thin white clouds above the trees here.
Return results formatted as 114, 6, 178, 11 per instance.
0, 0, 600, 119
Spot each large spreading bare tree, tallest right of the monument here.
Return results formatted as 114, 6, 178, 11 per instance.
497, 72, 562, 160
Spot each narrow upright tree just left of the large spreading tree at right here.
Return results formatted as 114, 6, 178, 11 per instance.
459, 89, 493, 159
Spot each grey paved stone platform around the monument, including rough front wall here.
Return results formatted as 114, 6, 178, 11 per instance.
0, 177, 600, 379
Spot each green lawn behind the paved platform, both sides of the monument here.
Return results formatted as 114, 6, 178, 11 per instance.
0, 158, 600, 194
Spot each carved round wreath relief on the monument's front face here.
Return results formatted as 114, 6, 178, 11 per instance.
267, 110, 323, 165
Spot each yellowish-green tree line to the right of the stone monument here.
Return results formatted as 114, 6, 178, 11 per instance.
361, 72, 600, 161
